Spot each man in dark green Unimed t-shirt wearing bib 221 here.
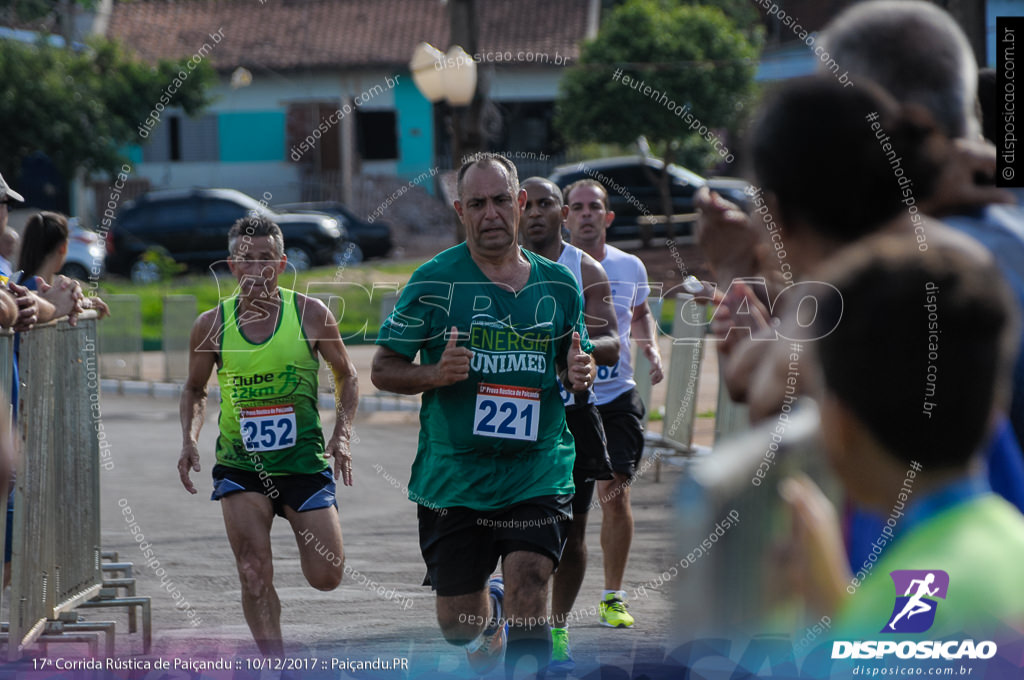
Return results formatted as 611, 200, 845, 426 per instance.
372, 154, 596, 673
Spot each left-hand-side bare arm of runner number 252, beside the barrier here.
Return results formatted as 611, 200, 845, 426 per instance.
178, 309, 219, 494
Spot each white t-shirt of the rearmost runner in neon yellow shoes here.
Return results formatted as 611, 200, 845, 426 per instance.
594, 245, 650, 406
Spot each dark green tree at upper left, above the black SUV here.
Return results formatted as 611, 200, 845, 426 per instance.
0, 34, 216, 181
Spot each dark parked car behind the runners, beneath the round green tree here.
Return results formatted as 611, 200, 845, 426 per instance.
549, 156, 750, 241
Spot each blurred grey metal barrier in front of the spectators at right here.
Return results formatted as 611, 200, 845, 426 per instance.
666, 400, 839, 648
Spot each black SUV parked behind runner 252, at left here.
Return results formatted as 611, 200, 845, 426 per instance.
106, 188, 352, 283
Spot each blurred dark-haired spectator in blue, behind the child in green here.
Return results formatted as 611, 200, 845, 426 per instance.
709, 76, 1024, 577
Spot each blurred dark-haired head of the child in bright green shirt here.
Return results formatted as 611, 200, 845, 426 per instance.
813, 236, 1018, 506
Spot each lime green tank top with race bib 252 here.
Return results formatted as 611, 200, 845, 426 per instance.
217, 288, 328, 475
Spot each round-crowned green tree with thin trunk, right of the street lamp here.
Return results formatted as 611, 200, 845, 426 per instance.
555, 0, 760, 244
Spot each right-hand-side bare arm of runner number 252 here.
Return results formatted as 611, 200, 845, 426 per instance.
299, 295, 359, 486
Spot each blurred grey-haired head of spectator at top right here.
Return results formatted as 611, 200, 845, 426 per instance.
822, 0, 979, 137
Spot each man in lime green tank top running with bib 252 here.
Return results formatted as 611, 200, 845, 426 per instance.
178, 215, 358, 656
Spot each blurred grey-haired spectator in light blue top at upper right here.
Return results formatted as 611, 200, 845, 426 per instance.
824, 0, 1024, 454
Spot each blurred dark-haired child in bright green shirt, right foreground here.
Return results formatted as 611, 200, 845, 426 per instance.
781, 236, 1024, 641
